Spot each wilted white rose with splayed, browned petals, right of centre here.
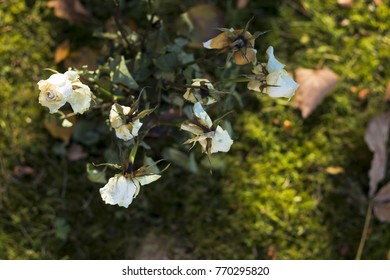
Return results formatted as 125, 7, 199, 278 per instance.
180, 102, 233, 154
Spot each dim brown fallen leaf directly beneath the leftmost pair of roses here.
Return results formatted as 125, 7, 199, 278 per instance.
44, 111, 76, 144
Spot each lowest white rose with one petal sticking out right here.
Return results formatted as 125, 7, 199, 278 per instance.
100, 174, 161, 208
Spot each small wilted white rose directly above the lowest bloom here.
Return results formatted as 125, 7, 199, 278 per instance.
110, 104, 142, 141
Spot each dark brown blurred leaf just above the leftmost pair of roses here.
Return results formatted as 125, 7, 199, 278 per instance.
64, 47, 99, 71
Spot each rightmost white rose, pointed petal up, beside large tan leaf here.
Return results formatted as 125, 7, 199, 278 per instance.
264, 46, 299, 98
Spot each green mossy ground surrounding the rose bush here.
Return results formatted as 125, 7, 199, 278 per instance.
0, 1, 390, 259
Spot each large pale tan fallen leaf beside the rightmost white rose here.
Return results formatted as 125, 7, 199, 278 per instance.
294, 67, 339, 118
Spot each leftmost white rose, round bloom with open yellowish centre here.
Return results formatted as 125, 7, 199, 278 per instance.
38, 73, 72, 113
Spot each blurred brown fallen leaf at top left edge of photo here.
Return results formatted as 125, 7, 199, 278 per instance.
47, 0, 90, 24
